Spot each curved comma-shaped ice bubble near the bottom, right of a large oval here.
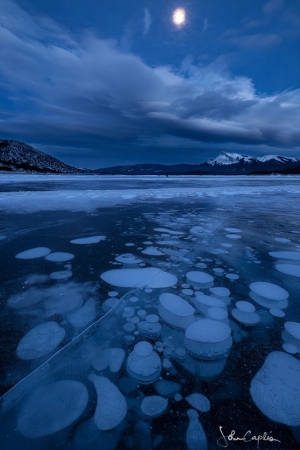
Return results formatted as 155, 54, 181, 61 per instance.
88, 374, 127, 431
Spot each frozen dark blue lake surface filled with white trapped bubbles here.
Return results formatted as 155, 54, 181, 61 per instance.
0, 174, 300, 450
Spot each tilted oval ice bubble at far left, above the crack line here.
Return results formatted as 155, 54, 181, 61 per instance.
17, 321, 66, 360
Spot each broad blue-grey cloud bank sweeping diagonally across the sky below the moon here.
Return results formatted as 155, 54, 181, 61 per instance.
0, 0, 300, 160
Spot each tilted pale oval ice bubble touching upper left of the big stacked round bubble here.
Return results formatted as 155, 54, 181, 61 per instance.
158, 293, 195, 329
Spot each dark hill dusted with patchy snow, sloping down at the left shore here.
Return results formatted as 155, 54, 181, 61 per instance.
0, 140, 81, 173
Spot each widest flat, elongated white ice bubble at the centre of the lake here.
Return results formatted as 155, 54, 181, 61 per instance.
101, 267, 177, 288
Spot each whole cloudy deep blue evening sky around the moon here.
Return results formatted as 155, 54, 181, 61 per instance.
0, 0, 300, 168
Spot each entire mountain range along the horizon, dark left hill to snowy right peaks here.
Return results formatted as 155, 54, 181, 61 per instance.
0, 140, 300, 175
